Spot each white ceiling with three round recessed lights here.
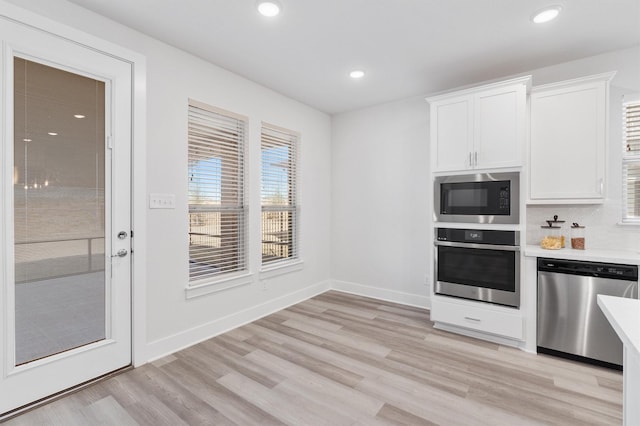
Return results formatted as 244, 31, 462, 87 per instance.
70, 0, 640, 114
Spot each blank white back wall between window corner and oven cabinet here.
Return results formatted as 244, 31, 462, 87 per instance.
331, 97, 431, 306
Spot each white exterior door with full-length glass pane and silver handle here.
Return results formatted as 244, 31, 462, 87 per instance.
0, 16, 135, 416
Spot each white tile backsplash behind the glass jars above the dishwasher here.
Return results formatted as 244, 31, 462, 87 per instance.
527, 203, 640, 251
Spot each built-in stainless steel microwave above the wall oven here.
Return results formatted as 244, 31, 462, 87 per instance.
434, 172, 520, 224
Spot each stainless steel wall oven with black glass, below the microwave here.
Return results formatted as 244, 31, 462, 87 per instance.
435, 228, 520, 308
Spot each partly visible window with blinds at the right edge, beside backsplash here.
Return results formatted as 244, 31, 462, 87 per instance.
622, 100, 640, 224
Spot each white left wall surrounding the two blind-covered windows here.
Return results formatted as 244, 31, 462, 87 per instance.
5, 0, 331, 359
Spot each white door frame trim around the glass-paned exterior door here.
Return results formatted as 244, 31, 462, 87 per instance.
0, 0, 148, 367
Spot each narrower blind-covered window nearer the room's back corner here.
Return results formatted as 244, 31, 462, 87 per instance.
260, 124, 299, 266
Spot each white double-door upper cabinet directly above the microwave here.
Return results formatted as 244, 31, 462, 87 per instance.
427, 77, 531, 172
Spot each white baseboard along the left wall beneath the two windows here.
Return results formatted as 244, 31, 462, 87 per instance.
145, 280, 332, 362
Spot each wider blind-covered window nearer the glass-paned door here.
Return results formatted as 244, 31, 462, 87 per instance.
188, 100, 247, 284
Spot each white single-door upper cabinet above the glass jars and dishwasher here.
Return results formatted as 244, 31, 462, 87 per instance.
528, 73, 615, 204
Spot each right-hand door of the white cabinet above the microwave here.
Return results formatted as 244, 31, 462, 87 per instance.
473, 85, 526, 168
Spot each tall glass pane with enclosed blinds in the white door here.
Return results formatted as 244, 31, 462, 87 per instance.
13, 58, 106, 365
